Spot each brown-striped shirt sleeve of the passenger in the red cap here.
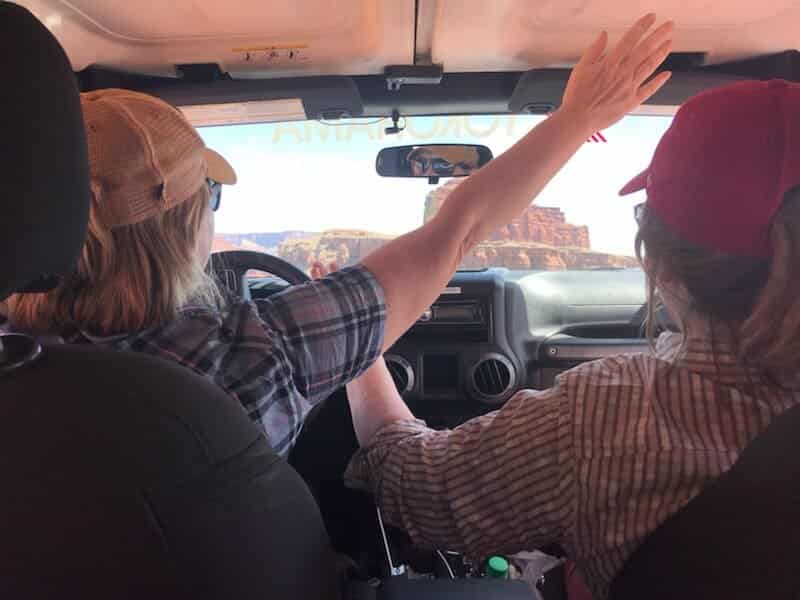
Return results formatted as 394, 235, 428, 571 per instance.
345, 388, 575, 558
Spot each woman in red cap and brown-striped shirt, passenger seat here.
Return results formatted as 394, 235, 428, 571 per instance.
348, 81, 800, 599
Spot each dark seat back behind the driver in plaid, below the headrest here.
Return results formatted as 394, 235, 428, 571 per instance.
0, 346, 337, 600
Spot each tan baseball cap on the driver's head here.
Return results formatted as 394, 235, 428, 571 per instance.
81, 89, 236, 229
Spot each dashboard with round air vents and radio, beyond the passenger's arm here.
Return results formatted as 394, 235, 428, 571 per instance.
386, 269, 647, 427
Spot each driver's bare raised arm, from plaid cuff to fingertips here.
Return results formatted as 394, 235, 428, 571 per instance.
362, 14, 672, 349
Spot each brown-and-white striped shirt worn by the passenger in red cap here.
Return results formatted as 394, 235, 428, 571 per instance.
346, 333, 800, 599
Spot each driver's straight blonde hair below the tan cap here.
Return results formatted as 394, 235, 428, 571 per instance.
8, 185, 220, 336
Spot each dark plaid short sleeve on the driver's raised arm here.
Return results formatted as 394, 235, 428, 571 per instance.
256, 266, 386, 403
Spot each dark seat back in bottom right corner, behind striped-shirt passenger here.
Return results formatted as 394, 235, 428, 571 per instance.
609, 406, 800, 600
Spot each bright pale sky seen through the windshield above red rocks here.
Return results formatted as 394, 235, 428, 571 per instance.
200, 115, 671, 255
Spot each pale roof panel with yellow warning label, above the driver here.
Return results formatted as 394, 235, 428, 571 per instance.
18, 0, 415, 79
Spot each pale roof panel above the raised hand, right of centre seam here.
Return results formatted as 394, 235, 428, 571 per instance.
432, 0, 800, 73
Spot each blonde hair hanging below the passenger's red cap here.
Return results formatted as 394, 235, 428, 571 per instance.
636, 188, 800, 376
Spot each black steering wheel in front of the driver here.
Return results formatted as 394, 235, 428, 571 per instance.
211, 250, 311, 300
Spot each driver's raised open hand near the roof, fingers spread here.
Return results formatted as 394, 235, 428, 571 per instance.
561, 13, 673, 131
